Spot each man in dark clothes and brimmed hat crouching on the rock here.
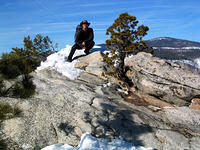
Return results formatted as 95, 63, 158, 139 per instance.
67, 20, 95, 62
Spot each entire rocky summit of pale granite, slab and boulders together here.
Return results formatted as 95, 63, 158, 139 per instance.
0, 52, 200, 150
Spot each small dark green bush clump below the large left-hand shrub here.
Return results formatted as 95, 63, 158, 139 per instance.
12, 75, 36, 98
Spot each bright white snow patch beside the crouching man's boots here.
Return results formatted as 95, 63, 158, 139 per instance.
37, 45, 85, 80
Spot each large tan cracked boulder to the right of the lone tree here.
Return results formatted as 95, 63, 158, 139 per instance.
125, 52, 200, 106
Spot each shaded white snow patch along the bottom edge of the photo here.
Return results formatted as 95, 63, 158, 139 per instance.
42, 133, 153, 150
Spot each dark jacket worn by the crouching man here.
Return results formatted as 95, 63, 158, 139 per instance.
75, 28, 94, 47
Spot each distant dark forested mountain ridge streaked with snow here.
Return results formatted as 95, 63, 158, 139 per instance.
99, 37, 200, 60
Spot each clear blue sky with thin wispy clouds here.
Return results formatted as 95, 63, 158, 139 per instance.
0, 0, 200, 53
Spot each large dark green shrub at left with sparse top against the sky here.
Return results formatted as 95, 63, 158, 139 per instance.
0, 34, 55, 79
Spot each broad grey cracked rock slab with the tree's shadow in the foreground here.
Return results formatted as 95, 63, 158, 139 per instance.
0, 69, 200, 150
